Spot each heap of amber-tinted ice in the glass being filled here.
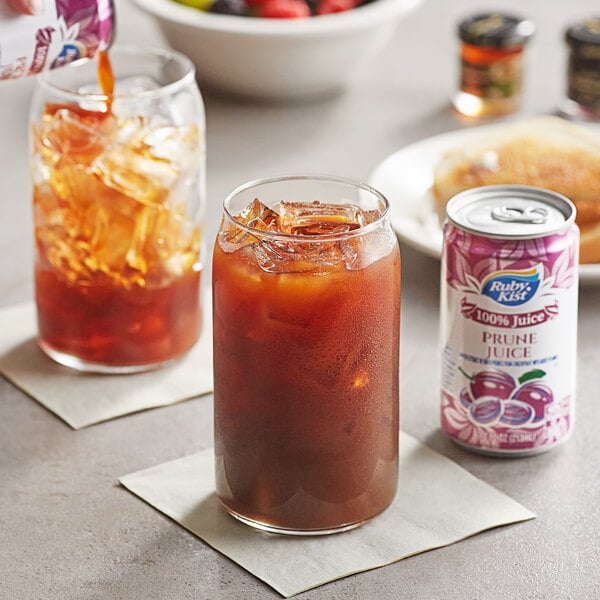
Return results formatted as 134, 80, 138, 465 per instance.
33, 107, 200, 287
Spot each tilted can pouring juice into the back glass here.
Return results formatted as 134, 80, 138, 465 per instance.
0, 0, 115, 80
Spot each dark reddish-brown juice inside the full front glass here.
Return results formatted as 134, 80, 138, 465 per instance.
213, 219, 400, 530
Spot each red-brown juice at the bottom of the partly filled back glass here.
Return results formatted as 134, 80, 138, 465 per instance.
35, 266, 201, 366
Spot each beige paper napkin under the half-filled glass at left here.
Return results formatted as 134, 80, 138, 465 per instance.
0, 298, 213, 429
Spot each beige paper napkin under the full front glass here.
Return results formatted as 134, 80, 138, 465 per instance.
120, 433, 535, 597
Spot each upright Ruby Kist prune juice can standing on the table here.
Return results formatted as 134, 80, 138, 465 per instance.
440, 185, 579, 456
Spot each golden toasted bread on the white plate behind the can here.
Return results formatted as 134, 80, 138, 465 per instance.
433, 116, 600, 263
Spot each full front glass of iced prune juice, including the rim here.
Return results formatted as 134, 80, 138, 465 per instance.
212, 175, 400, 535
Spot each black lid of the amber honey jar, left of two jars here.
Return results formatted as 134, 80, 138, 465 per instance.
458, 13, 535, 48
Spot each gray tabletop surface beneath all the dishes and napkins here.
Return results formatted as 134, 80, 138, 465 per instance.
0, 0, 600, 600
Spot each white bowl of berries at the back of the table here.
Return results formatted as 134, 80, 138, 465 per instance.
133, 0, 423, 100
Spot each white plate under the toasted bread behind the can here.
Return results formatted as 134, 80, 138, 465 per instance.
369, 125, 600, 283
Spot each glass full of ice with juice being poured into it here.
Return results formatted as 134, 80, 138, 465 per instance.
30, 47, 205, 373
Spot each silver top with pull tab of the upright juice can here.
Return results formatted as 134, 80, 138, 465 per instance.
446, 185, 576, 239
